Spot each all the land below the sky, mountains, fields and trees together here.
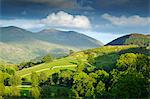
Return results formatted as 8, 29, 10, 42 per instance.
0, 27, 150, 99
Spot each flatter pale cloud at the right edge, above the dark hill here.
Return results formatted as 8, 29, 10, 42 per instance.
101, 13, 150, 26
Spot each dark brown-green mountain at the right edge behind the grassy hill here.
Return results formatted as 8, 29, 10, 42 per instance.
106, 34, 150, 46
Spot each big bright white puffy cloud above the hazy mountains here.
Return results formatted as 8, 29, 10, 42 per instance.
41, 11, 91, 29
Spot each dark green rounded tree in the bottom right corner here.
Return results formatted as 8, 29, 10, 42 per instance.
111, 70, 148, 98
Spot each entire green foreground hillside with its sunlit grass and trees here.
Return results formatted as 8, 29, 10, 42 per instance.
0, 45, 150, 99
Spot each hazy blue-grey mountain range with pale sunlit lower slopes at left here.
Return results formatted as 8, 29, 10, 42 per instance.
0, 26, 102, 63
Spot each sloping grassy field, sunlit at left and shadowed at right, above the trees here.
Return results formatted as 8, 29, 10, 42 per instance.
17, 45, 149, 77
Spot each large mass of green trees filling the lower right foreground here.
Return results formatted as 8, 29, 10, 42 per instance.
35, 53, 150, 98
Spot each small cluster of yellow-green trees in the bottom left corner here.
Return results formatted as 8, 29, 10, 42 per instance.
0, 71, 21, 97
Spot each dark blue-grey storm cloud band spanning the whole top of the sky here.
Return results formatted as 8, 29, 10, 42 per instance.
1, 0, 149, 18
